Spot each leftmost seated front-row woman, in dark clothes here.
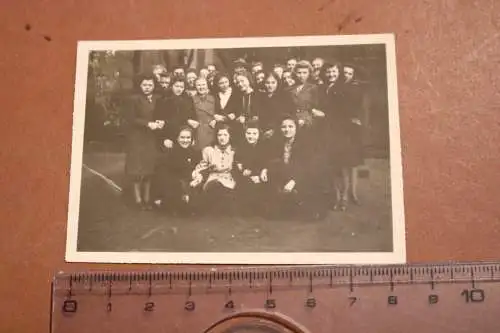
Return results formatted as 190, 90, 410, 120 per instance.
160, 126, 200, 214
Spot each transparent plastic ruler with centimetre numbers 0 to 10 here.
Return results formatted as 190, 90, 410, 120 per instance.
51, 263, 500, 333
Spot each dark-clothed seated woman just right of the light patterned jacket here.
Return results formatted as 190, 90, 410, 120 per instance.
234, 122, 267, 215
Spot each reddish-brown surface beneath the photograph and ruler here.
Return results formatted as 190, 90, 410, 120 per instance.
0, 0, 500, 332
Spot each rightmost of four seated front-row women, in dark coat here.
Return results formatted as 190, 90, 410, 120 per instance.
262, 115, 327, 219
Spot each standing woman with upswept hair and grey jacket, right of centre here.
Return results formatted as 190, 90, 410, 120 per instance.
290, 60, 325, 128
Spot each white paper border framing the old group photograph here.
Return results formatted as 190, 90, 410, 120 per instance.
65, 34, 406, 265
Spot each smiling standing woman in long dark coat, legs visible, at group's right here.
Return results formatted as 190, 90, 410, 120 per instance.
322, 63, 353, 211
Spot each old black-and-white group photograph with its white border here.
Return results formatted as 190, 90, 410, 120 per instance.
66, 34, 406, 264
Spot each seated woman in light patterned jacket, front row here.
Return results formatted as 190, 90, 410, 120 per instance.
190, 123, 236, 213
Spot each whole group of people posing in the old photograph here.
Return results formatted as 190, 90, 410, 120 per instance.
124, 54, 363, 219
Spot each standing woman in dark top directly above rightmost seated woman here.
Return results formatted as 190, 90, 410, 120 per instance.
255, 72, 295, 139
